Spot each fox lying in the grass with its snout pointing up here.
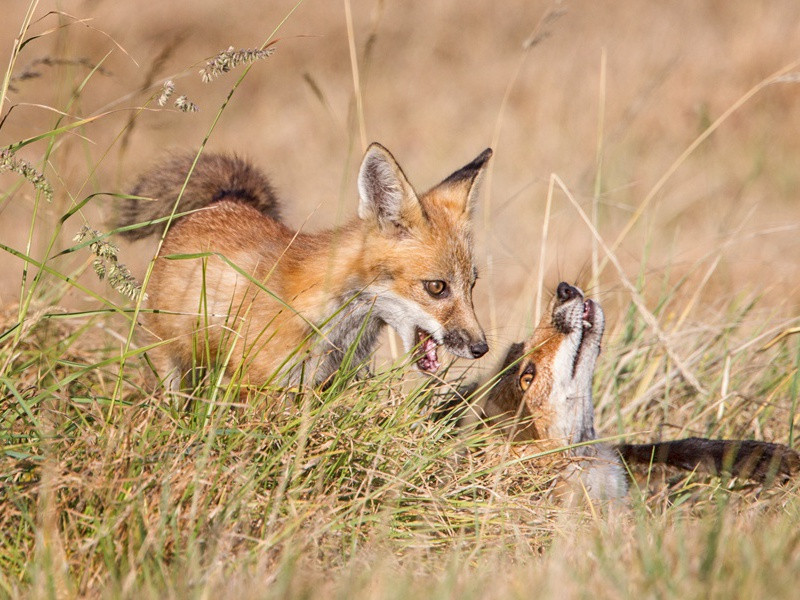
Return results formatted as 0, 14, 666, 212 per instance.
462, 283, 800, 500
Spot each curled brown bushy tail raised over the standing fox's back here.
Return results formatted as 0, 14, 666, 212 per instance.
116, 153, 279, 239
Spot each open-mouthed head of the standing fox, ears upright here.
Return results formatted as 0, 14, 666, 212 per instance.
358, 144, 492, 373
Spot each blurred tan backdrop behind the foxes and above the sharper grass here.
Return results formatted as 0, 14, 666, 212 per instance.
0, 0, 800, 366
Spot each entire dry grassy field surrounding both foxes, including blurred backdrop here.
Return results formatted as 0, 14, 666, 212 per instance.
0, 0, 800, 598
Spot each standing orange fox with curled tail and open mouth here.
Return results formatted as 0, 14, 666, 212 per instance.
118, 143, 492, 389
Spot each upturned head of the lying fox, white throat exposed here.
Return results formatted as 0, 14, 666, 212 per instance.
485, 282, 605, 443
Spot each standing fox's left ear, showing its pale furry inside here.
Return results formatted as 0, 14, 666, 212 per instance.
358, 143, 421, 229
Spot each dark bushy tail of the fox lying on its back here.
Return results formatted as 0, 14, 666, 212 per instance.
617, 438, 800, 481
